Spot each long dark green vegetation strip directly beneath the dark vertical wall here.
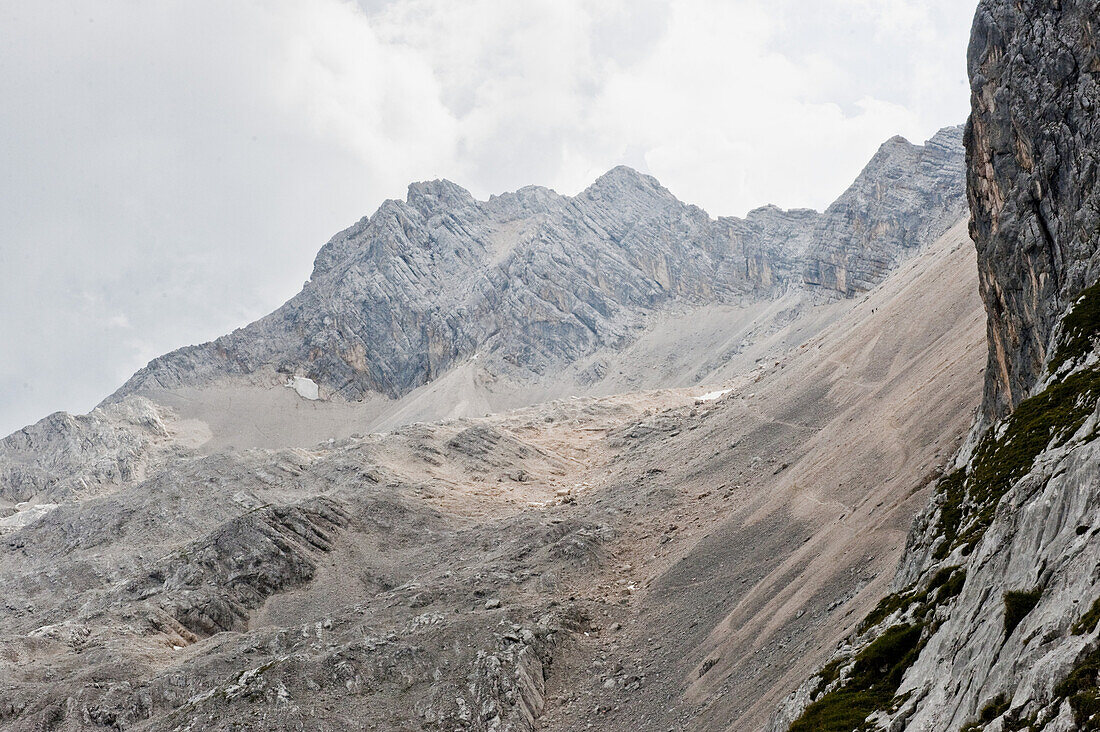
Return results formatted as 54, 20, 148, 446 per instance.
934, 368, 1100, 559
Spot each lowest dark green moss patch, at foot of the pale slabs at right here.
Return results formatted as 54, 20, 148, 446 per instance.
790, 623, 925, 732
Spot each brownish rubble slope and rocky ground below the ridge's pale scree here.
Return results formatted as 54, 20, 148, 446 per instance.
0, 217, 986, 732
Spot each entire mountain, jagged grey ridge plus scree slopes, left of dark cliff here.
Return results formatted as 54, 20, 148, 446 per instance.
0, 129, 985, 731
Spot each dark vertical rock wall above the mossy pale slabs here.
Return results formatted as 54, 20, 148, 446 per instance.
967, 0, 1100, 418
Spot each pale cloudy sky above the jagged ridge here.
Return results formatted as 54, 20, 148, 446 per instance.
0, 0, 976, 435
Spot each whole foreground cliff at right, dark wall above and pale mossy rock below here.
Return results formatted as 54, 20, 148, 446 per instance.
772, 0, 1100, 731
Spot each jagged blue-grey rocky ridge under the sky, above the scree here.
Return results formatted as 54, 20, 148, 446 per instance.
105, 128, 965, 401
